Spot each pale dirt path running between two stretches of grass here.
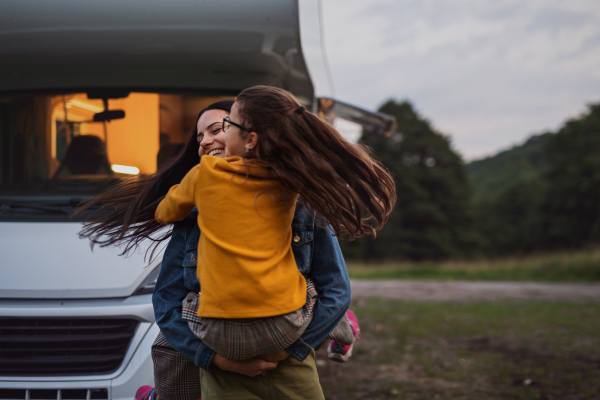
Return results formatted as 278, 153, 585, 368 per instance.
351, 279, 600, 301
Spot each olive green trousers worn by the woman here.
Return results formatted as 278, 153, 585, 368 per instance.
200, 351, 325, 400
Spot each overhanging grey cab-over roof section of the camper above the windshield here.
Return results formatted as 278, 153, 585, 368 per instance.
0, 0, 326, 103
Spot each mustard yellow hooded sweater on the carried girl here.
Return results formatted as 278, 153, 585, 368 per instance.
155, 156, 306, 318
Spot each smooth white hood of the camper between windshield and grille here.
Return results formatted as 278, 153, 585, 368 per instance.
0, 222, 157, 299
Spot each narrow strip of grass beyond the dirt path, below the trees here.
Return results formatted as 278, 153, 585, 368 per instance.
348, 249, 600, 282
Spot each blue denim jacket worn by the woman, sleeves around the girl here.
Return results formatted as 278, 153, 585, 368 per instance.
152, 205, 351, 371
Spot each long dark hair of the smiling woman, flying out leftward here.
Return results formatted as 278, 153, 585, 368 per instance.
77, 100, 233, 260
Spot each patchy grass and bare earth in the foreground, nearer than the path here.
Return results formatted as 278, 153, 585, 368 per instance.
317, 298, 600, 400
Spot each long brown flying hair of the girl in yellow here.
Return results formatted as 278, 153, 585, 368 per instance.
234, 86, 396, 239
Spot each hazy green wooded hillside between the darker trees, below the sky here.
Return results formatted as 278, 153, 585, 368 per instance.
466, 133, 550, 203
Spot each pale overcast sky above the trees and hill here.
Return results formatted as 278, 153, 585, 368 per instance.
322, 0, 600, 160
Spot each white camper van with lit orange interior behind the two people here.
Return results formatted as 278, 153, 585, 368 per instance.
0, 0, 394, 400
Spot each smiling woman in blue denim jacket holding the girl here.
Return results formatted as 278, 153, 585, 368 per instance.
82, 102, 350, 400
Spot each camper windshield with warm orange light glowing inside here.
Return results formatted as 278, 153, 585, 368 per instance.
0, 92, 232, 221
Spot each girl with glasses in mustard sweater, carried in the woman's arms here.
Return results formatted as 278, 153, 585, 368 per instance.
155, 86, 395, 359
